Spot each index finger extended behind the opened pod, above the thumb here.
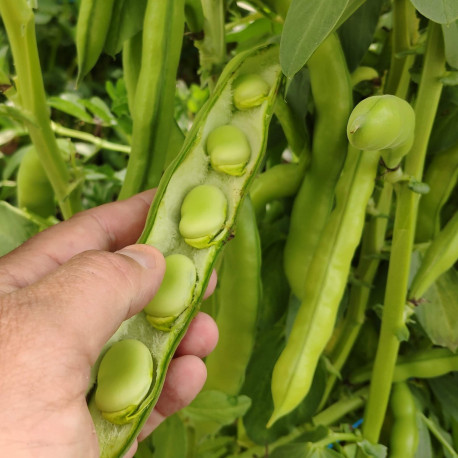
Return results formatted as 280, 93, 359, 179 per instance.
0, 190, 155, 293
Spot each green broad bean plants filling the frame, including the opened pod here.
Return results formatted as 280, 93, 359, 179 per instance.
0, 0, 458, 458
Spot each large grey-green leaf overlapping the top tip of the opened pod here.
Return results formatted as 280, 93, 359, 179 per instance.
280, 0, 348, 78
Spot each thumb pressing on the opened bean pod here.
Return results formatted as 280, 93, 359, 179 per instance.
18, 245, 165, 364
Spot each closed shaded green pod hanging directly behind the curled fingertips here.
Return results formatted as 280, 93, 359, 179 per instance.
204, 198, 261, 396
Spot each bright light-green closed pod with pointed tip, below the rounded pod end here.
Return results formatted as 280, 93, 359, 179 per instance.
267, 147, 380, 427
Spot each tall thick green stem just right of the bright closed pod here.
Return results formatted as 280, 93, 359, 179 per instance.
363, 22, 445, 443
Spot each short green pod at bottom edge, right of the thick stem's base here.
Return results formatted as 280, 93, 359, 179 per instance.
390, 382, 418, 458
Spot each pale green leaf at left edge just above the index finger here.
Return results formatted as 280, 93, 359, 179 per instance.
0, 201, 47, 256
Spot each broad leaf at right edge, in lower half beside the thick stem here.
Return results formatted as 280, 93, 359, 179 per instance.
415, 269, 458, 352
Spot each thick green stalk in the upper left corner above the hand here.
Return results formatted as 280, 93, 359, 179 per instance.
0, 0, 81, 219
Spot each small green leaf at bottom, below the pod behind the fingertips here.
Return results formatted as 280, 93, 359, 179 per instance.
182, 391, 251, 425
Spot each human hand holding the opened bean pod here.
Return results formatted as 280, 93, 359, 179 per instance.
0, 191, 218, 458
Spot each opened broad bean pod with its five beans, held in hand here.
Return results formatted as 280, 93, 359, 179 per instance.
84, 44, 281, 457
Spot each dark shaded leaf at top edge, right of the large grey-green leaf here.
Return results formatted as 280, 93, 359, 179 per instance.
338, 0, 383, 72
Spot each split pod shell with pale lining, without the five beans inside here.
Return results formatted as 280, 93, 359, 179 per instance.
89, 44, 281, 457
